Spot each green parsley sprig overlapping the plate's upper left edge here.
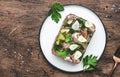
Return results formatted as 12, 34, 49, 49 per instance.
48, 3, 64, 23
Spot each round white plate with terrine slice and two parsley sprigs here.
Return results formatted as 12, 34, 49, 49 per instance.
39, 3, 106, 72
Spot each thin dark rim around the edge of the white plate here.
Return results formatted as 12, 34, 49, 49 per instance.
38, 4, 108, 73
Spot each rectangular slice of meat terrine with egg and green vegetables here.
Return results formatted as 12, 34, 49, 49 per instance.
52, 14, 95, 64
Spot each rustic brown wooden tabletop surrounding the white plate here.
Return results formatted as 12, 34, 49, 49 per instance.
0, 0, 120, 77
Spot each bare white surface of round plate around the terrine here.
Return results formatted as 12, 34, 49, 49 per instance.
40, 5, 106, 72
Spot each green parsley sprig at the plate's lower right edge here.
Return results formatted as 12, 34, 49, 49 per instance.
83, 55, 98, 71
